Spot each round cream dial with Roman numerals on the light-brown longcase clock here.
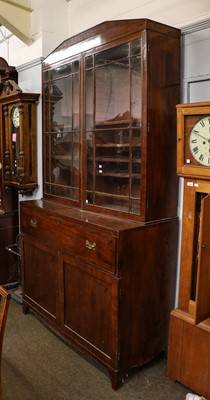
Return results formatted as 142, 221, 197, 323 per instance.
189, 115, 210, 167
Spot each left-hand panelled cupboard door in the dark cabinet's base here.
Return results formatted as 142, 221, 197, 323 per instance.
21, 235, 58, 322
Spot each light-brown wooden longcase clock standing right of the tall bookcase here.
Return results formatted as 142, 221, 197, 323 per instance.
167, 102, 210, 399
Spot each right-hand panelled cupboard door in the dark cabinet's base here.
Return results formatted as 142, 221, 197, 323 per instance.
60, 254, 118, 364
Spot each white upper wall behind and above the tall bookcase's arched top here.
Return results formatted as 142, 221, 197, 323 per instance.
0, 0, 210, 66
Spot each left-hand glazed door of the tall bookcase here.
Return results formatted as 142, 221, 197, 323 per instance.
43, 60, 80, 203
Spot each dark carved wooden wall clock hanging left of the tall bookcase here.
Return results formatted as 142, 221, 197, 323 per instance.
0, 79, 39, 192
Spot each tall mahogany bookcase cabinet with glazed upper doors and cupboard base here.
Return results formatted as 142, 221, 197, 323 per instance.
20, 19, 180, 389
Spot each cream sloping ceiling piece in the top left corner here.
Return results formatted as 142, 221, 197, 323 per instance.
0, 0, 33, 45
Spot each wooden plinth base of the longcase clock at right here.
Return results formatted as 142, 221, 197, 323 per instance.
167, 310, 210, 400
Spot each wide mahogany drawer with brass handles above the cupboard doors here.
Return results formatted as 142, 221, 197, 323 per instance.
20, 207, 116, 273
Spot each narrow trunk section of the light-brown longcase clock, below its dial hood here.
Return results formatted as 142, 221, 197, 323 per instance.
178, 179, 210, 324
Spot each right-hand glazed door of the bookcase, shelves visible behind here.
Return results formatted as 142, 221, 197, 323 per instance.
85, 38, 142, 214
